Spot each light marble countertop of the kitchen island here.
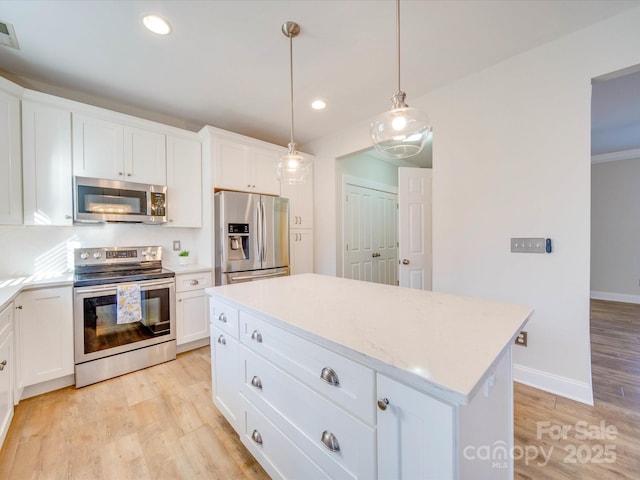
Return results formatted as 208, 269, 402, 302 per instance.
205, 274, 533, 404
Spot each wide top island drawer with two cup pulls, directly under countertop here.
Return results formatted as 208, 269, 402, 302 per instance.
240, 311, 375, 425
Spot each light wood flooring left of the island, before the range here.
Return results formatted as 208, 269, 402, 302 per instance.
0, 347, 269, 480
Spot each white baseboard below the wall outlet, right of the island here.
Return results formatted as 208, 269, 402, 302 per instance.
513, 364, 593, 405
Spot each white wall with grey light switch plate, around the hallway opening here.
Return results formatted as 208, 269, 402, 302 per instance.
305, 8, 640, 403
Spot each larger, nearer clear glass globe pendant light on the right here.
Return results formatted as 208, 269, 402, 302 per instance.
369, 0, 431, 159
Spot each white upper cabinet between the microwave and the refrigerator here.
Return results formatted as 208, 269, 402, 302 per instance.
167, 135, 202, 228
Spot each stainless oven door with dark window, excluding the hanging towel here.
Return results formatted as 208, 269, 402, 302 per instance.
73, 278, 176, 364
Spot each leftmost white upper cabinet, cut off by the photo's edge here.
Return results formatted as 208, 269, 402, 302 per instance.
0, 80, 22, 225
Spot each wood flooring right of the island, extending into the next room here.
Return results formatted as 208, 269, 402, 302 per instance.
515, 300, 640, 480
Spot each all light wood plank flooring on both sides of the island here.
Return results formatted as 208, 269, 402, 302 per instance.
0, 301, 640, 480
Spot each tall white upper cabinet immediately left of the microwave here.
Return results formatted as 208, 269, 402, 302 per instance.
22, 92, 73, 225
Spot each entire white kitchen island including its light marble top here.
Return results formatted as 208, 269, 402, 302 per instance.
206, 274, 532, 480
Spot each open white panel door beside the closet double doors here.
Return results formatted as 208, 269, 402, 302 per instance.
398, 167, 432, 290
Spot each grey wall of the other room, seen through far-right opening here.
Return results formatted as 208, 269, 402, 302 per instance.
591, 158, 640, 303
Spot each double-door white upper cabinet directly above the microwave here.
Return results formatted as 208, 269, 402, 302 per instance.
73, 112, 167, 185
